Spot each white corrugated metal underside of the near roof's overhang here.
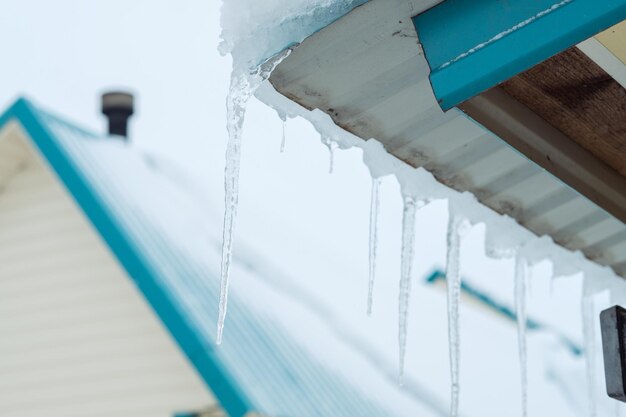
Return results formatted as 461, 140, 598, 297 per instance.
270, 0, 626, 277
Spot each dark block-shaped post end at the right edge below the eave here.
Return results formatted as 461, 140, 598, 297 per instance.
600, 306, 626, 402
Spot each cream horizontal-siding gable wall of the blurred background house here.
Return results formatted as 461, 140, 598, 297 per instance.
0, 125, 215, 417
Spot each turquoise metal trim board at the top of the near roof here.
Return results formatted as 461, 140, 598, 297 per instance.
413, 0, 626, 110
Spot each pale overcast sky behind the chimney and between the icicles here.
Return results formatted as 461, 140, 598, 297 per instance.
0, 0, 616, 416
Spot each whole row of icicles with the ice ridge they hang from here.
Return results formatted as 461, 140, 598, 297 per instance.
217, 5, 615, 417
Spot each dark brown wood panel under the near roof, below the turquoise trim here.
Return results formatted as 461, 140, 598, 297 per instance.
500, 48, 626, 177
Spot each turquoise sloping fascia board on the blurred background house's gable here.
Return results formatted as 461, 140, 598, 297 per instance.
0, 98, 253, 417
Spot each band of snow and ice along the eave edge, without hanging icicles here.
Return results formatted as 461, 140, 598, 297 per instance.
255, 82, 626, 292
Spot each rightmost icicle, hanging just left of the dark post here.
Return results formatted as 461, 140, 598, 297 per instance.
581, 277, 597, 417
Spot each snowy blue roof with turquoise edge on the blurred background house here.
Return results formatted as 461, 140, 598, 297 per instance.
0, 99, 391, 417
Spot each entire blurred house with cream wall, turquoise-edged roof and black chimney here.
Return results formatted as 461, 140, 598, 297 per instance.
0, 98, 400, 416
